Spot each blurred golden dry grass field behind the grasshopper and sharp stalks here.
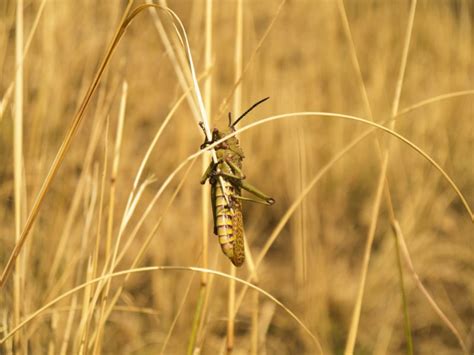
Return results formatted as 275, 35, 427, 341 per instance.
0, 0, 474, 354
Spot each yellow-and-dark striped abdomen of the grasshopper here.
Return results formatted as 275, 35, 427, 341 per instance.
214, 179, 245, 266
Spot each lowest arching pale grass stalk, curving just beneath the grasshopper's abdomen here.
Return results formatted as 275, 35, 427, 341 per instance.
0, 266, 323, 353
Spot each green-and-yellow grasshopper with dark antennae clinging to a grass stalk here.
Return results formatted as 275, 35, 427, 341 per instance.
200, 97, 275, 266
